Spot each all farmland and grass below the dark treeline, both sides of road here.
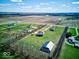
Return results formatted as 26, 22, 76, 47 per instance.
0, 16, 79, 59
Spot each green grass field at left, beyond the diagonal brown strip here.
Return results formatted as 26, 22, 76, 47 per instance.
0, 23, 40, 42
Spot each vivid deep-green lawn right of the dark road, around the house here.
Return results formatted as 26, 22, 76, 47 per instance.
59, 28, 79, 59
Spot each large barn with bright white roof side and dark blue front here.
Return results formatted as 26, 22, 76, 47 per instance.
40, 41, 54, 53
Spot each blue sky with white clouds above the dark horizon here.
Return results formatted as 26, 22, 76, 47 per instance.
0, 0, 79, 13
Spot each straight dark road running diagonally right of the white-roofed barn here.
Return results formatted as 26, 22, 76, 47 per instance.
50, 27, 68, 59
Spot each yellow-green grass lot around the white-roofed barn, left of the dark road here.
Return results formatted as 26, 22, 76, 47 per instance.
15, 27, 64, 59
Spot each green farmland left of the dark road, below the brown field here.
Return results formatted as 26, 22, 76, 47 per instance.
0, 21, 64, 59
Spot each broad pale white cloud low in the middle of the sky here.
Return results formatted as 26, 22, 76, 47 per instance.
20, 5, 56, 12
